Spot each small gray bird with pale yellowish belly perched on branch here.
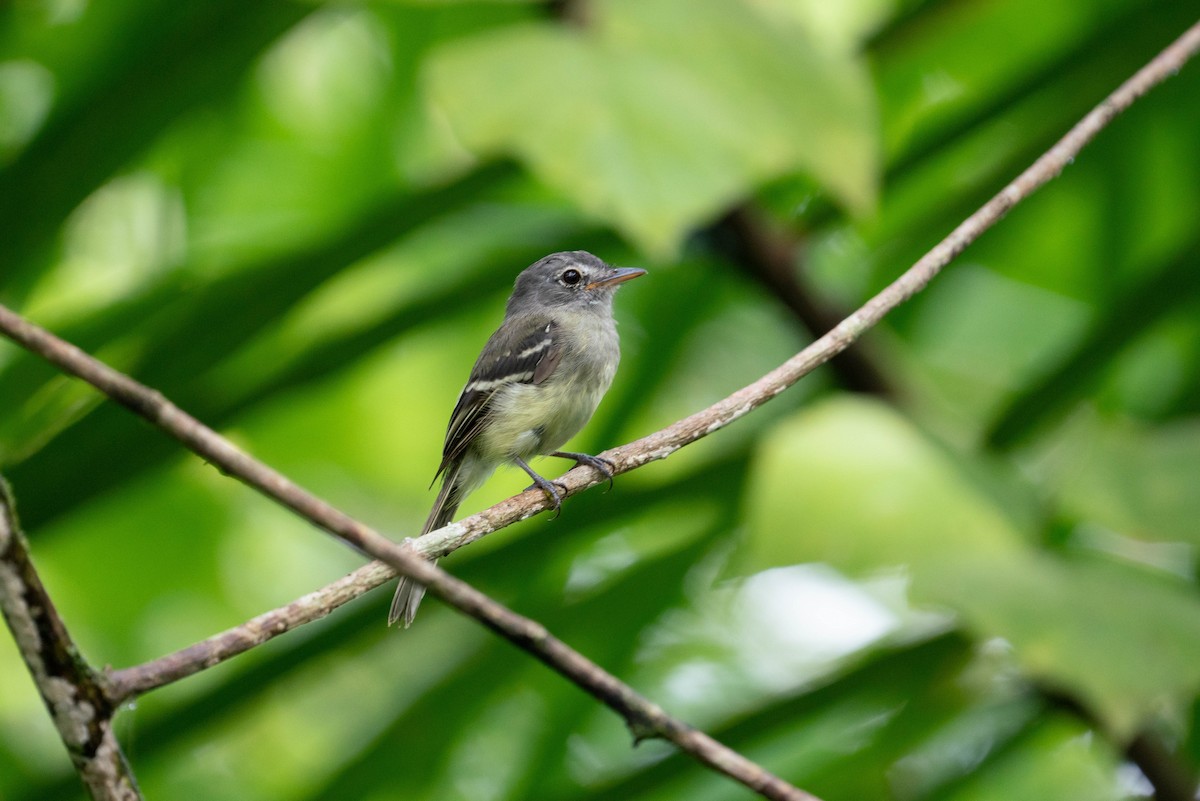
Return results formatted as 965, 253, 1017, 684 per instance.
388, 251, 646, 628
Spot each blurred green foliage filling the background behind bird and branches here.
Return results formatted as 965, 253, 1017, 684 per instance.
0, 0, 1200, 801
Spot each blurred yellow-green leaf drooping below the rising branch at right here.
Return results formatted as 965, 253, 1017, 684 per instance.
748, 401, 1200, 733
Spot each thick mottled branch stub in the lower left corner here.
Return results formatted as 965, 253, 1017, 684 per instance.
0, 480, 142, 801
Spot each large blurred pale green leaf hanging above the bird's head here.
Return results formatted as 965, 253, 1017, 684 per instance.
426, 0, 878, 254
